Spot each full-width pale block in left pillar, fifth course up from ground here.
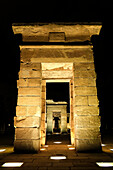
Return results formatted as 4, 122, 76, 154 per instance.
17, 96, 41, 106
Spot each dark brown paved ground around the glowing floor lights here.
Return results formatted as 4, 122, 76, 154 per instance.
0, 134, 113, 170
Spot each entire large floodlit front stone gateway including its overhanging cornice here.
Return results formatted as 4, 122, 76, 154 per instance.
12, 23, 101, 152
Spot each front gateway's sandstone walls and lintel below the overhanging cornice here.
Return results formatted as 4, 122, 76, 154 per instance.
15, 45, 101, 152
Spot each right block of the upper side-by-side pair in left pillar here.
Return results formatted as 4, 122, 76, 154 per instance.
28, 78, 41, 87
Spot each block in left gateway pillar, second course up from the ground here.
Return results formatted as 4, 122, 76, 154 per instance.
15, 127, 40, 140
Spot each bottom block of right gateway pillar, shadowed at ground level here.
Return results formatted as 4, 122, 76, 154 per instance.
75, 138, 102, 152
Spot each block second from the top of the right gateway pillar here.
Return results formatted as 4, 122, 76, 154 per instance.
74, 69, 96, 78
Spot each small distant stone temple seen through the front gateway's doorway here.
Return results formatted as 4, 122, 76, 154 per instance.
46, 100, 67, 133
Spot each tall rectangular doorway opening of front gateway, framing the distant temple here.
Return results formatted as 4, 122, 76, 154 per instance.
46, 81, 70, 144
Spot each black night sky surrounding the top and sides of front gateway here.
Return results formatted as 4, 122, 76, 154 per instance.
0, 0, 113, 131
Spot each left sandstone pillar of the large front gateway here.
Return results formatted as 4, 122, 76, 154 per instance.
14, 62, 42, 152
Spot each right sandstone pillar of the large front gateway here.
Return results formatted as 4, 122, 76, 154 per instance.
74, 58, 101, 152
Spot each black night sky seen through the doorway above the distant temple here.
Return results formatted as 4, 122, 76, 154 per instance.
46, 83, 70, 113
